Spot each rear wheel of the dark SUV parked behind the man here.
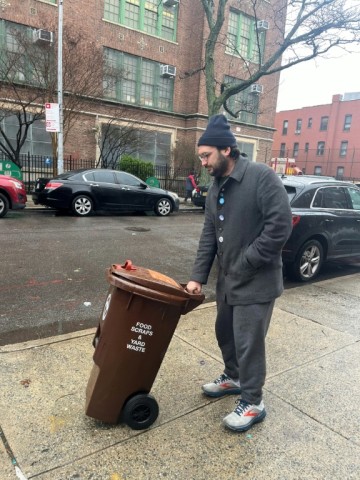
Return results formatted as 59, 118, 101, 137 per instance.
287, 240, 324, 282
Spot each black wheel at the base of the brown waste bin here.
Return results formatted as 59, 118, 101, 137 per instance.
122, 393, 159, 430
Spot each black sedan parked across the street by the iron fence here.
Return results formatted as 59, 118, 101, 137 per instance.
32, 169, 180, 217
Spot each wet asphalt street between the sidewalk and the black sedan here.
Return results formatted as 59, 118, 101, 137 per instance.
0, 206, 360, 345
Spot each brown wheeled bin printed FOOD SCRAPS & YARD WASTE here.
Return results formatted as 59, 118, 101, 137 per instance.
86, 260, 204, 430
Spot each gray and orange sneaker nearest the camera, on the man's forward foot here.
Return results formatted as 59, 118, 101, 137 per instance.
224, 399, 266, 432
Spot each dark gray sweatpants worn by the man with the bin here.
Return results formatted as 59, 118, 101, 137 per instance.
215, 300, 275, 405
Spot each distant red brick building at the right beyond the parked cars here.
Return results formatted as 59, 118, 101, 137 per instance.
272, 92, 360, 180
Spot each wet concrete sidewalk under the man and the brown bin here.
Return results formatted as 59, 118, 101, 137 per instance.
0, 274, 360, 480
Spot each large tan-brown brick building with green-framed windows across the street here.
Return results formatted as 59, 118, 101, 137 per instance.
0, 0, 284, 169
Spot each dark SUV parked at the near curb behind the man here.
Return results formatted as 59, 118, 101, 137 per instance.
281, 175, 360, 282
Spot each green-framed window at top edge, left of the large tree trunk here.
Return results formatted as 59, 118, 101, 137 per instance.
104, 0, 178, 41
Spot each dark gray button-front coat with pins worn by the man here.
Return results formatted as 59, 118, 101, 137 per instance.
191, 158, 292, 305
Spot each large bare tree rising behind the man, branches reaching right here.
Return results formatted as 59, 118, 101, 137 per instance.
197, 0, 360, 117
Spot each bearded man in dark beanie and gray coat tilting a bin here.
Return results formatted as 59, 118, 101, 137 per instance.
186, 115, 292, 432
